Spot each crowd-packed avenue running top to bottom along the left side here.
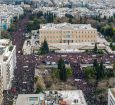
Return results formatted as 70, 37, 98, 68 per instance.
4, 13, 35, 105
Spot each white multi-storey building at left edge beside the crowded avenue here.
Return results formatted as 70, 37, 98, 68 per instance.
0, 39, 16, 90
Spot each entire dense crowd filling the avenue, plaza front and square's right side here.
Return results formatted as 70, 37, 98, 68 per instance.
4, 10, 115, 105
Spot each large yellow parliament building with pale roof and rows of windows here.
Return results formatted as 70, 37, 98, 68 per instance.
39, 23, 97, 44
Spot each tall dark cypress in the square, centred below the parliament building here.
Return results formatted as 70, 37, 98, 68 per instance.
58, 58, 67, 82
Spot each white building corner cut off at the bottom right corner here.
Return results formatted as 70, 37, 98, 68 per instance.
108, 88, 115, 105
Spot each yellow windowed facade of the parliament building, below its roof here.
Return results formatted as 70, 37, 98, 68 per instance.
39, 29, 97, 43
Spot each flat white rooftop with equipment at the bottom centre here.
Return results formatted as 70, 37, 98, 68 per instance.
16, 90, 87, 105
